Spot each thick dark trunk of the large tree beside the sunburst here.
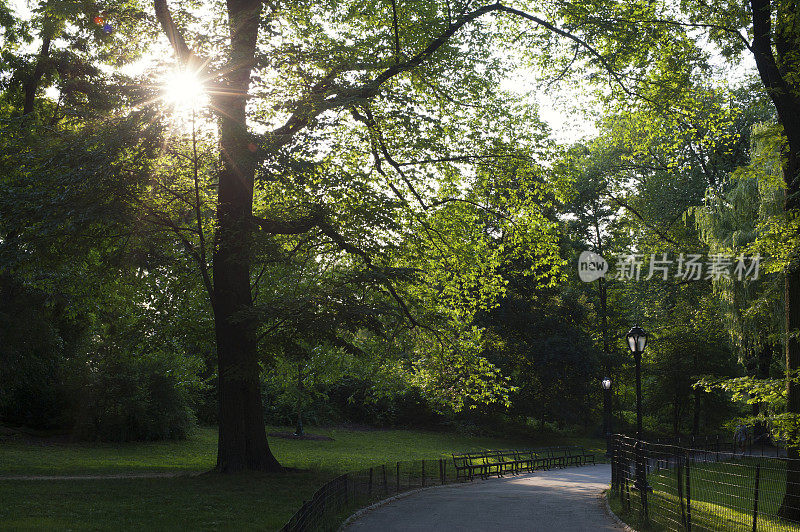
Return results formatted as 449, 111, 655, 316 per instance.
212, 0, 281, 472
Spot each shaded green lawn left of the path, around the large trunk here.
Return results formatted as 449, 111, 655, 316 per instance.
0, 427, 605, 530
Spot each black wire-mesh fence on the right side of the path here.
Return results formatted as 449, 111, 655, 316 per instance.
611, 435, 800, 532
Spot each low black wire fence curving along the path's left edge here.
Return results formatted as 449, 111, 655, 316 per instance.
281, 458, 464, 532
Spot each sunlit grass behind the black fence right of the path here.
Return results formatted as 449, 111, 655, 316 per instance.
609, 458, 800, 532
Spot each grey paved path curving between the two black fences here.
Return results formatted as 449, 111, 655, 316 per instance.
346, 464, 621, 532
